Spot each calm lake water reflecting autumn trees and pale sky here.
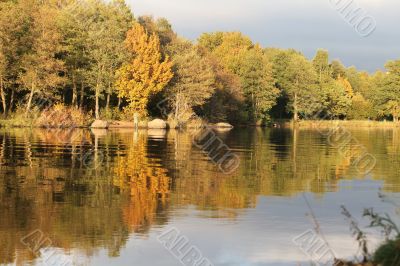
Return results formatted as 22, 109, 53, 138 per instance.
0, 129, 400, 266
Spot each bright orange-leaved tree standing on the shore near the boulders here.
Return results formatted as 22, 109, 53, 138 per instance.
116, 23, 173, 115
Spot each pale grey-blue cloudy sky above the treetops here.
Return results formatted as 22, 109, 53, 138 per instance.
126, 0, 400, 72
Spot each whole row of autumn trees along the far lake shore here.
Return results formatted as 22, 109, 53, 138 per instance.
0, 0, 400, 125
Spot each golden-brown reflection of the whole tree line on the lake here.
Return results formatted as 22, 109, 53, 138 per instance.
0, 128, 400, 264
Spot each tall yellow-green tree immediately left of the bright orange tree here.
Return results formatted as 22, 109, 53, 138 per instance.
87, 1, 133, 119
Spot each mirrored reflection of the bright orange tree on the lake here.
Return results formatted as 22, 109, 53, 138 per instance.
113, 134, 170, 227
